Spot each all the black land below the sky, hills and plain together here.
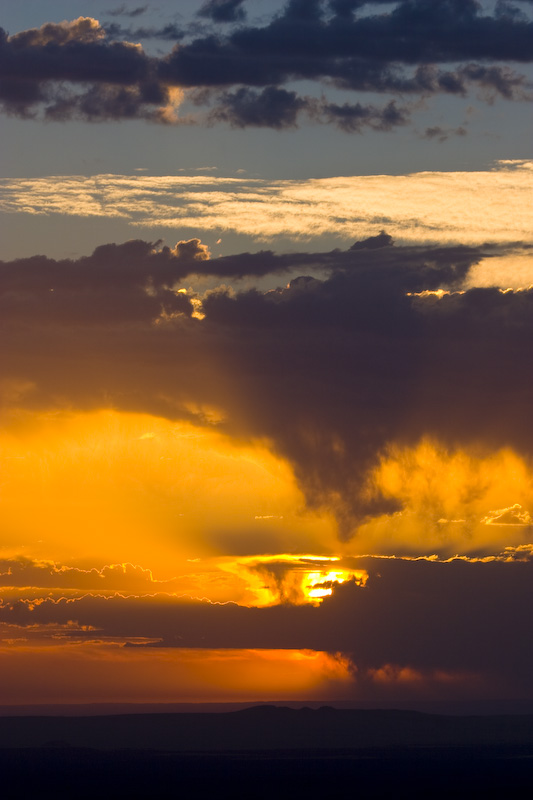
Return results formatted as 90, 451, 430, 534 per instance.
0, 707, 533, 800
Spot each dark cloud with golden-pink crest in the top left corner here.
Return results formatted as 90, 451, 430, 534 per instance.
0, 17, 181, 123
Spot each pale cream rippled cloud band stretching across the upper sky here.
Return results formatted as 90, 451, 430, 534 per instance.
0, 162, 533, 250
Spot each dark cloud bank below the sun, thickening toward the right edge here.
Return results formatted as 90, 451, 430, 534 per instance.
0, 558, 533, 697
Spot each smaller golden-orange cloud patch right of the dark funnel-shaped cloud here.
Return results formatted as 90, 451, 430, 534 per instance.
358, 439, 533, 555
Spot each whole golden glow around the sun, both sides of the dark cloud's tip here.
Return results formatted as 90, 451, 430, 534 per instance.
0, 411, 533, 576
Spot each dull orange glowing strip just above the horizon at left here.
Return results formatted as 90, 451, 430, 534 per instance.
0, 641, 352, 705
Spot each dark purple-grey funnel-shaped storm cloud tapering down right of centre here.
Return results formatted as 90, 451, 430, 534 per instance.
196, 251, 533, 532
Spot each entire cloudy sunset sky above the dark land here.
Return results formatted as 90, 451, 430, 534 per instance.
0, 0, 533, 707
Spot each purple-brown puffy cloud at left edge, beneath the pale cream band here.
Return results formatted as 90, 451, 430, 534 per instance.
0, 239, 216, 325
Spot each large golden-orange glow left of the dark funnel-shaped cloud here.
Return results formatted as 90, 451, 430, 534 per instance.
0, 411, 335, 580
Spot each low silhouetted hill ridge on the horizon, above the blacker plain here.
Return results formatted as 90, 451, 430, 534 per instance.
0, 706, 533, 752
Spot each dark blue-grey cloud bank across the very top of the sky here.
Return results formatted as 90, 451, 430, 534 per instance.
0, 0, 533, 125
